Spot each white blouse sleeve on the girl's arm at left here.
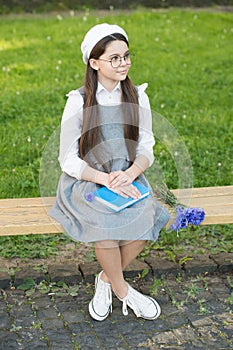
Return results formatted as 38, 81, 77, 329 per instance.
58, 90, 87, 180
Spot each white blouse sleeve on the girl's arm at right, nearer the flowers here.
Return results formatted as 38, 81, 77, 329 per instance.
136, 83, 155, 166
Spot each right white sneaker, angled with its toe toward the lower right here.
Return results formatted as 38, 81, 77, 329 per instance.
118, 284, 161, 320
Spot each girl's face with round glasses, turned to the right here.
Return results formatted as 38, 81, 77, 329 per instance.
90, 40, 130, 91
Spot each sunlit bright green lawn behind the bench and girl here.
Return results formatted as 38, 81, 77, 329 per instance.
0, 10, 233, 255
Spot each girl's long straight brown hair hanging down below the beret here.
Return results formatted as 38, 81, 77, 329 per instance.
79, 33, 139, 170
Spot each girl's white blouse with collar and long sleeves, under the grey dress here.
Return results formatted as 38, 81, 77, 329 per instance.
58, 82, 155, 180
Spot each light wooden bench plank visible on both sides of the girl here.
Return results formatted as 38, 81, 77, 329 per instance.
0, 186, 233, 236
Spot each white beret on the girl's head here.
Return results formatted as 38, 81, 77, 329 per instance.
81, 23, 128, 64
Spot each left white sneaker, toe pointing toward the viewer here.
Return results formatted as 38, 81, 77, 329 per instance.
89, 271, 112, 321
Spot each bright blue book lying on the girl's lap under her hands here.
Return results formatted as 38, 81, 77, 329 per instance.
94, 181, 150, 212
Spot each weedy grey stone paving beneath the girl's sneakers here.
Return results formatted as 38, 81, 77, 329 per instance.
0, 253, 233, 350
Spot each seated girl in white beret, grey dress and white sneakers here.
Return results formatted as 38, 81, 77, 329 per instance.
50, 23, 169, 321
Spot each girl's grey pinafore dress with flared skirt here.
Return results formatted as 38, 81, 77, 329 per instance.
49, 97, 170, 243
